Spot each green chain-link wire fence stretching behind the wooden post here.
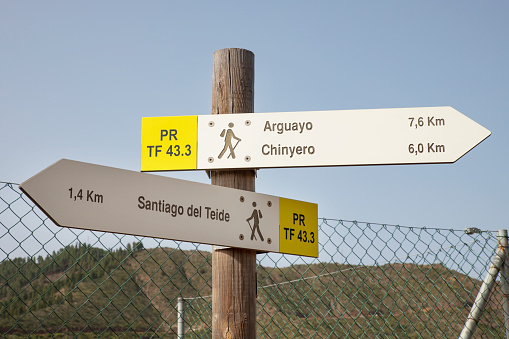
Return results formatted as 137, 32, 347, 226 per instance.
0, 183, 505, 338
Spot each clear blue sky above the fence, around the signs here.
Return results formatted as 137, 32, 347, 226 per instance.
0, 0, 509, 234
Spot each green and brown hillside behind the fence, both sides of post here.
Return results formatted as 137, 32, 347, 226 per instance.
0, 243, 502, 338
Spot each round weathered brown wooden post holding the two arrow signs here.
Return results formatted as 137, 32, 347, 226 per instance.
210, 48, 256, 339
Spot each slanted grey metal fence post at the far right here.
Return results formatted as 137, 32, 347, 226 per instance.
459, 230, 507, 339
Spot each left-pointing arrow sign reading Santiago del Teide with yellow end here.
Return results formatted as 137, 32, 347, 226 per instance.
20, 159, 318, 257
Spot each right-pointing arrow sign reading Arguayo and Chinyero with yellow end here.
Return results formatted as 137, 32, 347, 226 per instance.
141, 107, 491, 171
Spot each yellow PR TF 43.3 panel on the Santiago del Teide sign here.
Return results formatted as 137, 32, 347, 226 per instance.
279, 198, 318, 258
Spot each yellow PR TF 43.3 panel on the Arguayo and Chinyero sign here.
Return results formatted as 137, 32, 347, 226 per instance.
141, 115, 198, 172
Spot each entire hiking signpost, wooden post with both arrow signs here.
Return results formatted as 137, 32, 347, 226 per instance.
20, 48, 491, 339
